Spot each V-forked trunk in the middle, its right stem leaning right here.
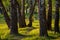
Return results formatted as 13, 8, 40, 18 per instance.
28, 0, 36, 27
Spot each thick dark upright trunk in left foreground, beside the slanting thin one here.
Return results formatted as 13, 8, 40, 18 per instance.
10, 0, 18, 34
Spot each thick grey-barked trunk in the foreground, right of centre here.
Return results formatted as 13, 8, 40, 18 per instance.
38, 0, 48, 36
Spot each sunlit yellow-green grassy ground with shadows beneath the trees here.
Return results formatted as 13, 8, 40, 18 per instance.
0, 20, 60, 40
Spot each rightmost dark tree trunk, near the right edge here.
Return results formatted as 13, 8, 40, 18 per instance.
54, 0, 59, 32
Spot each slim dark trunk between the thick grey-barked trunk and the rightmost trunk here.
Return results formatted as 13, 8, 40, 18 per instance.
47, 0, 52, 30
